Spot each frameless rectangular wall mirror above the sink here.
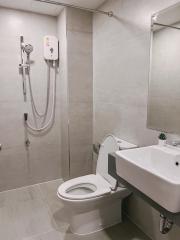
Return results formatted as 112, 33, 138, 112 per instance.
147, 3, 180, 134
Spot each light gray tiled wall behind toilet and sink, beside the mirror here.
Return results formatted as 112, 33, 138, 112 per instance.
93, 0, 180, 240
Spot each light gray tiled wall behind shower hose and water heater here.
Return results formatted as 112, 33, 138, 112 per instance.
0, 8, 61, 191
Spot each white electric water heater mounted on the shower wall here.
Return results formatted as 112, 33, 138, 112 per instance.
44, 36, 59, 61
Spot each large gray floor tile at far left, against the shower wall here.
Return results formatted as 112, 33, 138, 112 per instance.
0, 185, 53, 240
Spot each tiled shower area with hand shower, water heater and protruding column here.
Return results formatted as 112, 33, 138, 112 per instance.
0, 1, 93, 192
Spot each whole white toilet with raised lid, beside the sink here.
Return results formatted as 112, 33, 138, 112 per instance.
57, 135, 136, 235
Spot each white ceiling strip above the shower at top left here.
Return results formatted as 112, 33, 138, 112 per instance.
0, 0, 105, 16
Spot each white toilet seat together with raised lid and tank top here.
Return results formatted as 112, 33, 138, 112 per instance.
57, 135, 135, 201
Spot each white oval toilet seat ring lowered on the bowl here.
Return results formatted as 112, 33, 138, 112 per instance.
57, 174, 111, 200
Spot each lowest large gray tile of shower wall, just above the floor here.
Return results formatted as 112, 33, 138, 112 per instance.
0, 143, 61, 191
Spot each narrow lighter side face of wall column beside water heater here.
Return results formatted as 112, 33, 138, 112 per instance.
57, 9, 70, 180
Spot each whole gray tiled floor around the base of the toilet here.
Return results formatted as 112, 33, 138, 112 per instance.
0, 180, 149, 240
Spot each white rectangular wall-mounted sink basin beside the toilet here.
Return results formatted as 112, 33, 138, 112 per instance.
116, 145, 180, 213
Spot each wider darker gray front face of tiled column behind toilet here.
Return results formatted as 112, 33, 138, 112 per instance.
67, 8, 93, 178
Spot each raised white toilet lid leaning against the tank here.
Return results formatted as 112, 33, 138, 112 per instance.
96, 135, 120, 188
